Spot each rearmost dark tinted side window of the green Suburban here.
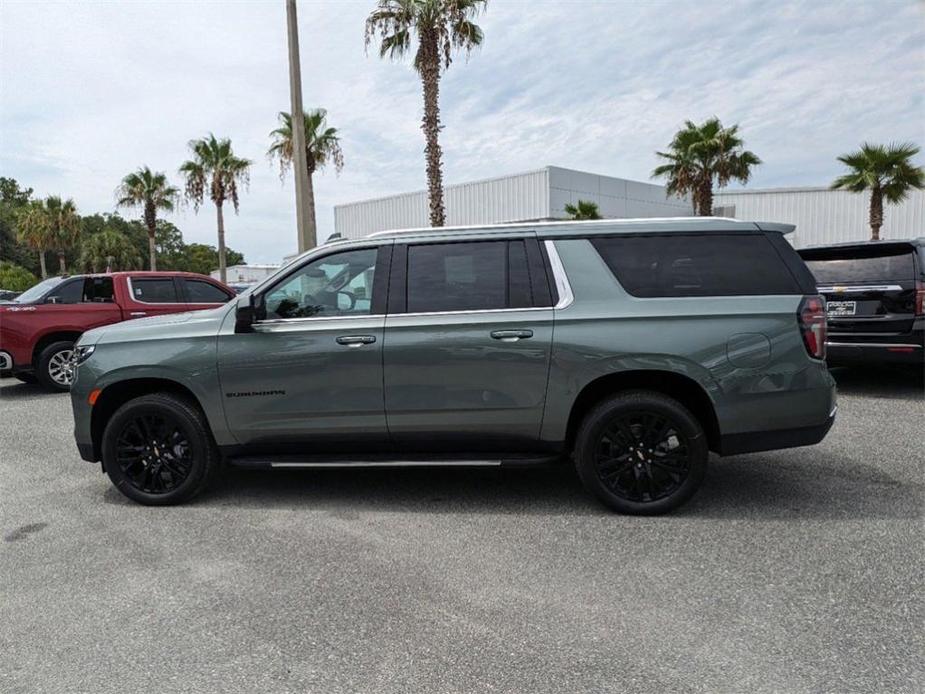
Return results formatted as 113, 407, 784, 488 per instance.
591, 233, 802, 298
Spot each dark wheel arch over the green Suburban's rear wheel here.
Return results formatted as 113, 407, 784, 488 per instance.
566, 370, 720, 452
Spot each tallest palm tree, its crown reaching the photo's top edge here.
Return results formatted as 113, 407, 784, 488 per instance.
366, 0, 488, 227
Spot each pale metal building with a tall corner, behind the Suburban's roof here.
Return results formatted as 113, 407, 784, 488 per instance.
334, 166, 692, 239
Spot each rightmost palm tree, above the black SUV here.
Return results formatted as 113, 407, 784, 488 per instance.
832, 142, 925, 241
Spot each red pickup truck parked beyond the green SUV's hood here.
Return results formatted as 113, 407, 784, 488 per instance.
0, 272, 235, 390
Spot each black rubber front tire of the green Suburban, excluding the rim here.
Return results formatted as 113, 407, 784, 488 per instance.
102, 397, 211, 506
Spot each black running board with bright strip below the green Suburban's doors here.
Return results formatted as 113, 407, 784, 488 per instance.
228, 453, 561, 470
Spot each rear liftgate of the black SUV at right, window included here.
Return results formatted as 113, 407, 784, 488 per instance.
800, 242, 917, 342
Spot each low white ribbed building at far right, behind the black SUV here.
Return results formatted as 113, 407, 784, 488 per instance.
713, 188, 925, 248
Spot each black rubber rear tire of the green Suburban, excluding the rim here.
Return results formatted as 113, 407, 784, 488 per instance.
575, 392, 709, 515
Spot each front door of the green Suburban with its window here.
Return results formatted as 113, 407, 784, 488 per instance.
218, 245, 391, 454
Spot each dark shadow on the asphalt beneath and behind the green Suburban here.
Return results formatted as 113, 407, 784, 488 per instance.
106, 451, 925, 520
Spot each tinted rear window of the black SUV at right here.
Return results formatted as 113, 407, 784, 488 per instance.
801, 247, 915, 284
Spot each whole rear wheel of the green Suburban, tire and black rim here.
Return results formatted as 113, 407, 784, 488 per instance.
575, 390, 709, 515
